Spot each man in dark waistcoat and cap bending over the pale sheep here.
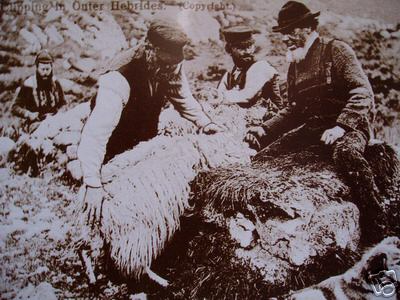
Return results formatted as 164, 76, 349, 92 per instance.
78, 20, 220, 222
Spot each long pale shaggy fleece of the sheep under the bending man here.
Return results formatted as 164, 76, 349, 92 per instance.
89, 133, 250, 278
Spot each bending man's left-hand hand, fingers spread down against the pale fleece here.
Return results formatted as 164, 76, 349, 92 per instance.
83, 186, 105, 227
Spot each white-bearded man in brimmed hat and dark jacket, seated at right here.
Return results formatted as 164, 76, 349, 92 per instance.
246, 1, 383, 242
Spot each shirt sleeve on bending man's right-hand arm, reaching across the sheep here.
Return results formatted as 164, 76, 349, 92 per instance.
166, 64, 211, 128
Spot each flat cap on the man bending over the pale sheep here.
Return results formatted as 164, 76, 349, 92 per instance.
147, 19, 189, 63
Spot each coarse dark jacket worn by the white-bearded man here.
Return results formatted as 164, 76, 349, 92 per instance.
263, 38, 375, 137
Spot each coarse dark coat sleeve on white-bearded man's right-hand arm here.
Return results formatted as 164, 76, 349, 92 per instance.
332, 41, 375, 131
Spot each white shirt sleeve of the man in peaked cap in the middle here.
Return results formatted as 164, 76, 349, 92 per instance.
224, 60, 278, 103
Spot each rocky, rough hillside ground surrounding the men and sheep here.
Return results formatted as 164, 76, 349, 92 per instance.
0, 0, 400, 299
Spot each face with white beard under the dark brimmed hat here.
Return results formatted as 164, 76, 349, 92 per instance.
282, 28, 312, 62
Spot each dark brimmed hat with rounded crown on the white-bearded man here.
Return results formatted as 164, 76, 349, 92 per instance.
272, 1, 320, 32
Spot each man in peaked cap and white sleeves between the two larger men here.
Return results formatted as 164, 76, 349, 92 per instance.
218, 25, 284, 109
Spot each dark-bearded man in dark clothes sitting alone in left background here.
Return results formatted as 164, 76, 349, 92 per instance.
12, 50, 65, 131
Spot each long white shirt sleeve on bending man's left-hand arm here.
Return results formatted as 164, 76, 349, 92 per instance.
78, 71, 130, 187
